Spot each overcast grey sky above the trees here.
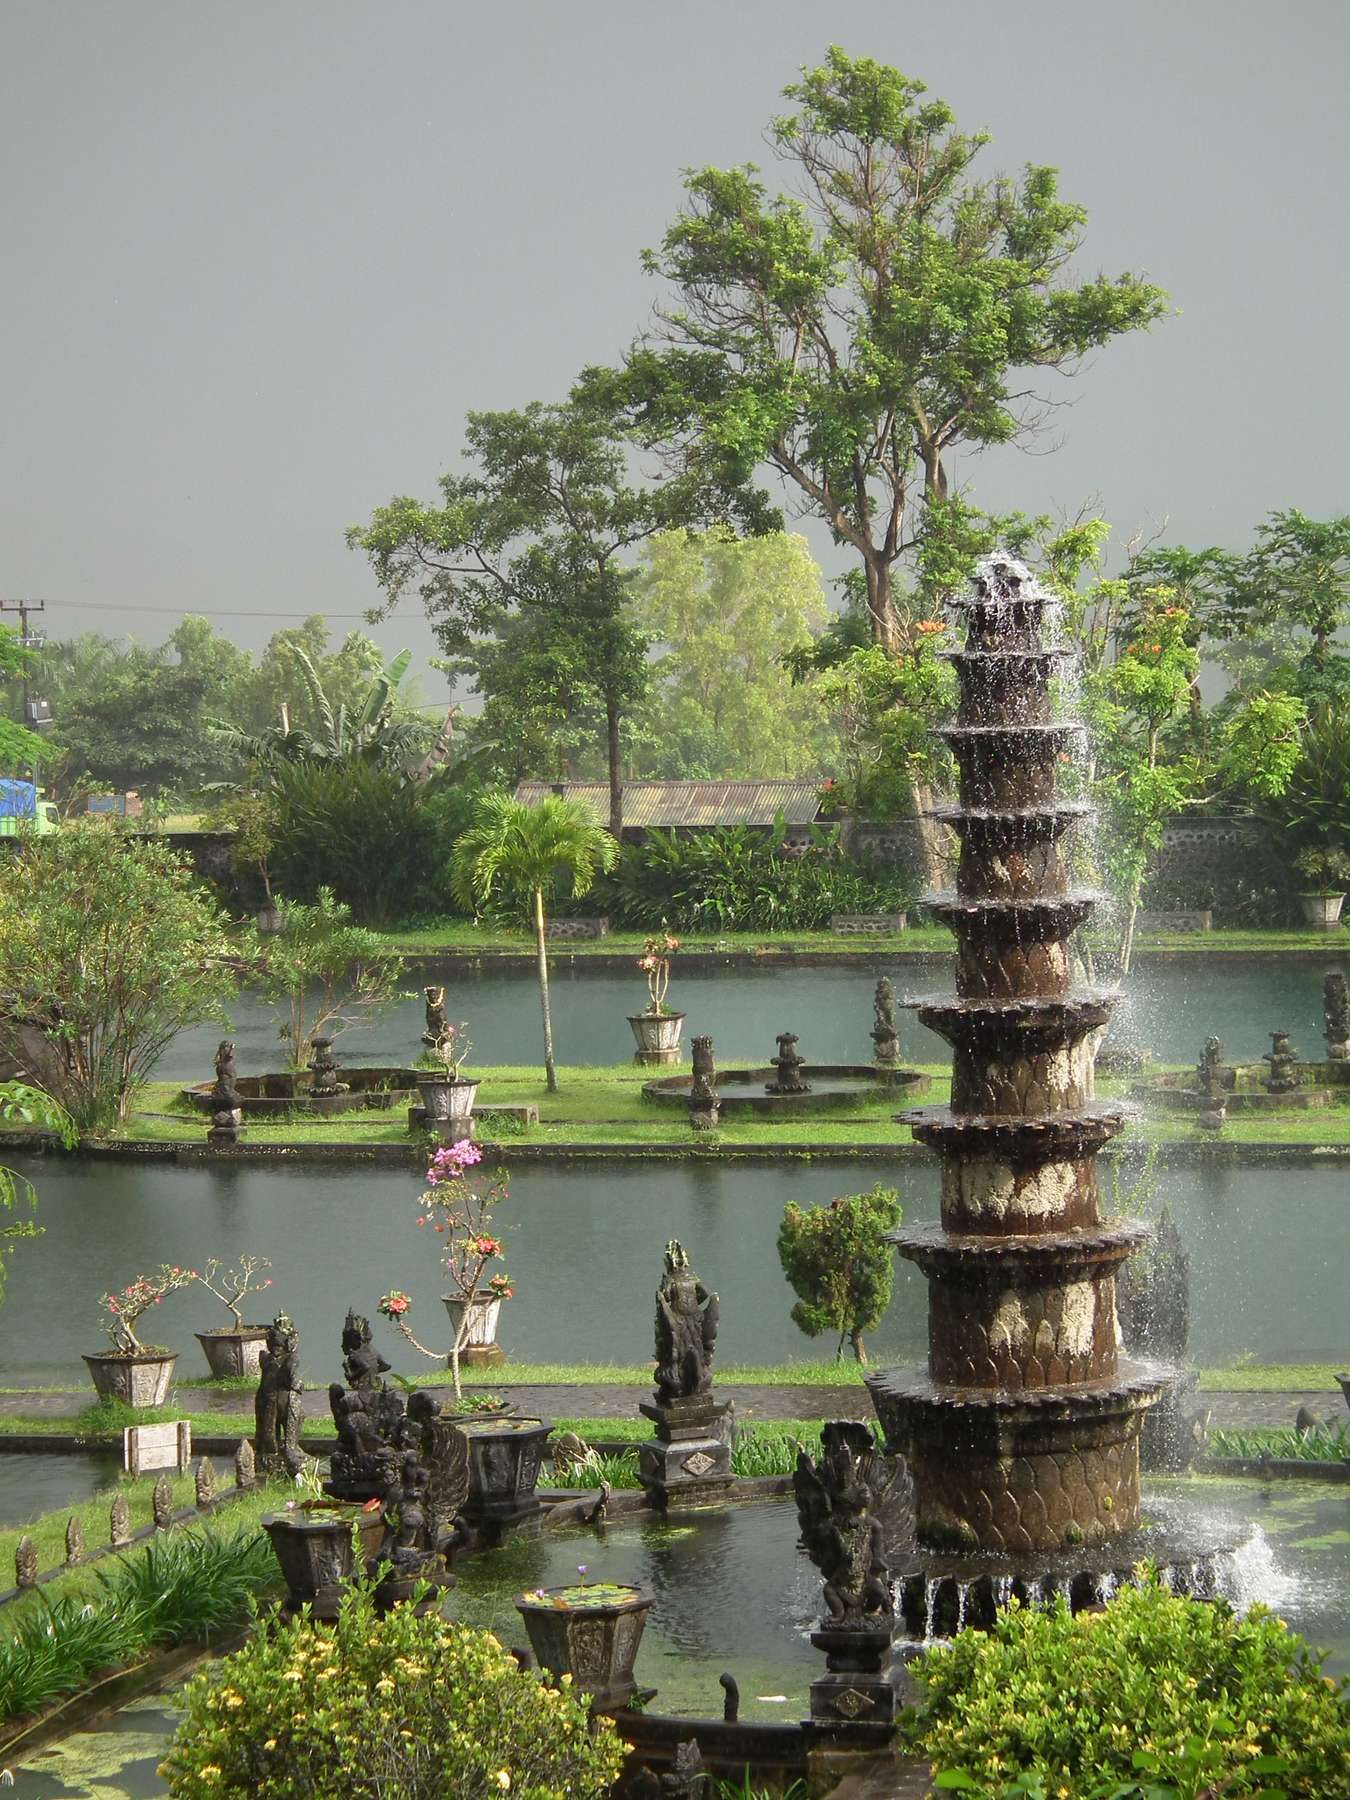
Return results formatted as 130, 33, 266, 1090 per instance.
0, 0, 1350, 693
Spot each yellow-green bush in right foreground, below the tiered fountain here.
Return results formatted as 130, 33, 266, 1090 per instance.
913, 1575, 1350, 1800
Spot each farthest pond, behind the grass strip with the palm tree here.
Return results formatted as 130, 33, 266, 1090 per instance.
160, 945, 1350, 1080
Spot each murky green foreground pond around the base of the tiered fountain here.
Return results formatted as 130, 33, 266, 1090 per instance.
13, 1481, 1350, 1800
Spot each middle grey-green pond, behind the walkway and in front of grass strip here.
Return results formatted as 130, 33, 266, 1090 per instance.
0, 1157, 1350, 1382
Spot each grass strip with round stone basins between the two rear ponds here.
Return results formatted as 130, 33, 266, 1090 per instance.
42, 1064, 1350, 1163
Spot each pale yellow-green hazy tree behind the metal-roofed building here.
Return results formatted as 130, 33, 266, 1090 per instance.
634, 526, 833, 778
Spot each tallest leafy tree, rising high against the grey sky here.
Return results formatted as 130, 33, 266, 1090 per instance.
581, 47, 1165, 650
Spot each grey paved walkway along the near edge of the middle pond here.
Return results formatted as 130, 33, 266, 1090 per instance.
0, 1381, 1350, 1444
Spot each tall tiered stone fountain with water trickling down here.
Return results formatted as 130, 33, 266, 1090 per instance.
868, 556, 1213, 1636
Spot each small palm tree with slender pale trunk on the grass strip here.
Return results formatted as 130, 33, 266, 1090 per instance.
450, 794, 619, 1094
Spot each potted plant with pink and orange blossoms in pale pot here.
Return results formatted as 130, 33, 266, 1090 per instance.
380, 1138, 515, 1397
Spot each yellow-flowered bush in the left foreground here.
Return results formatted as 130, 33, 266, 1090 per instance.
160, 1588, 625, 1800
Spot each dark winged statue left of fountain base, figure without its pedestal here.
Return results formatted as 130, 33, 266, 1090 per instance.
792, 1418, 895, 1625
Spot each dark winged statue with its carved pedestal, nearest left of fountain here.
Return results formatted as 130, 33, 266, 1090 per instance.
792, 1418, 900, 1737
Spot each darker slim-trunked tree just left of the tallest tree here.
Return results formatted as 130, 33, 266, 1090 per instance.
347, 401, 752, 832
